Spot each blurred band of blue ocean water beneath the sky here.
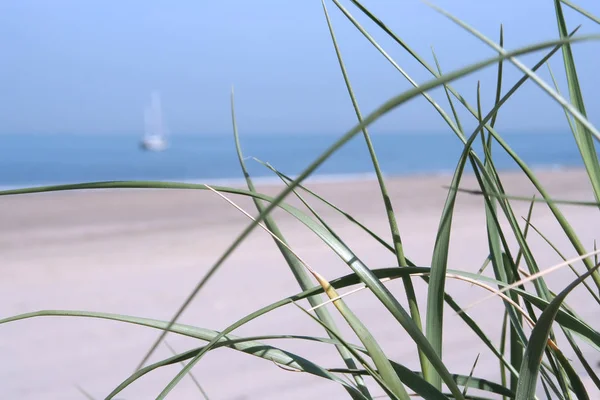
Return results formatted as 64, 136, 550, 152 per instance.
0, 132, 582, 188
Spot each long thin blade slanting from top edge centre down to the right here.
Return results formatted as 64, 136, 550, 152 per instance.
321, 0, 428, 378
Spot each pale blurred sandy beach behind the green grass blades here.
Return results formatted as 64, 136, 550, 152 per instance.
0, 170, 600, 400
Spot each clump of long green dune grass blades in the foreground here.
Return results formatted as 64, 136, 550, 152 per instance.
0, 0, 600, 400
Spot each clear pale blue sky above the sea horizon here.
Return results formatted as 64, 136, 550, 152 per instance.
0, 0, 600, 135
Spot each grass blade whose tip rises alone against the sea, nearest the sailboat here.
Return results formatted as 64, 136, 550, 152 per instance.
231, 89, 371, 398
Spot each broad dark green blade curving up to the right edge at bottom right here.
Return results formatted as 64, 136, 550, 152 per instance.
515, 265, 600, 400
